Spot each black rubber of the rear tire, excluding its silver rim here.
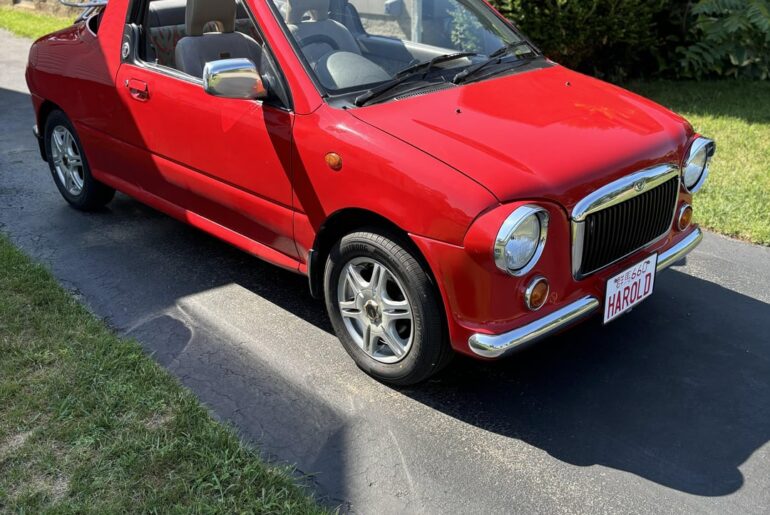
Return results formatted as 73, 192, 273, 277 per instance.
44, 111, 115, 211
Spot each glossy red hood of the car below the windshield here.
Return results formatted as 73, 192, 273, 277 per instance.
350, 65, 692, 209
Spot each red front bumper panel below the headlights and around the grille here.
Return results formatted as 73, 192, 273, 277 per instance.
412, 203, 695, 357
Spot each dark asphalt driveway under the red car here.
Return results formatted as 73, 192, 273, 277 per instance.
0, 32, 770, 513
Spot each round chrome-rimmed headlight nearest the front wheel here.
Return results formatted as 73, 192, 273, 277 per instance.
494, 205, 548, 276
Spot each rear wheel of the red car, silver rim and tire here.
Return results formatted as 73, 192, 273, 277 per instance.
45, 111, 115, 211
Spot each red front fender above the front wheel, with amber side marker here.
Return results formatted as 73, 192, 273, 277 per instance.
292, 106, 497, 251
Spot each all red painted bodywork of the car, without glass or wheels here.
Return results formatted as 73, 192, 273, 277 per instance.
27, 0, 695, 354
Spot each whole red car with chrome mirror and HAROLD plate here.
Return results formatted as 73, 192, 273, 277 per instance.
27, 0, 715, 385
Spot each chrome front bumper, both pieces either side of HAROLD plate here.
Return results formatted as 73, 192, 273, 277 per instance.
468, 227, 703, 358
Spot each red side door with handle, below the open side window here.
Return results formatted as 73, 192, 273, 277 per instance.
116, 2, 297, 258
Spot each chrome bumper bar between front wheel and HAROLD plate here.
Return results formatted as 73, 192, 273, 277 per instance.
468, 296, 599, 358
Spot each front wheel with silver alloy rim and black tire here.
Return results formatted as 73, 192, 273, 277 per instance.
324, 231, 453, 386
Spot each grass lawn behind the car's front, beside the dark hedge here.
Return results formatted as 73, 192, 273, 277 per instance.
628, 80, 770, 245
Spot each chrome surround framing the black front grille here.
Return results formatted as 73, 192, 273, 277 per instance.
571, 164, 681, 280
